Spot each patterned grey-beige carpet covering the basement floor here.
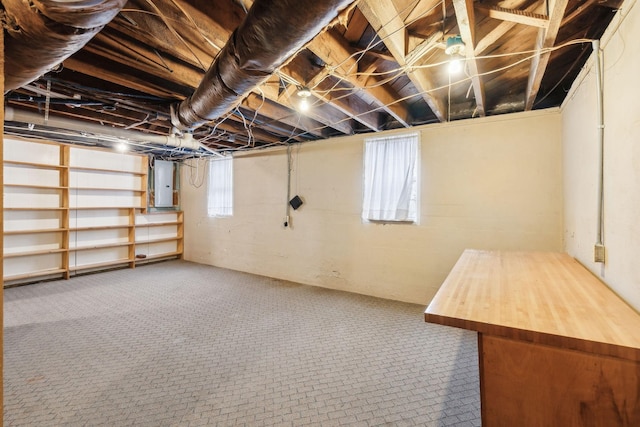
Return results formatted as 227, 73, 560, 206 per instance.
4, 261, 480, 426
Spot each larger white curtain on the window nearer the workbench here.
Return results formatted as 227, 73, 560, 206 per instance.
362, 134, 418, 222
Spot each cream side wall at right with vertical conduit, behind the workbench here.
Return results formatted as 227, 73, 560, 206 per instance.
562, 1, 640, 310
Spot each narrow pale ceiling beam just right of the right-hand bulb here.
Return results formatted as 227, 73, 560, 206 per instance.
453, 0, 486, 116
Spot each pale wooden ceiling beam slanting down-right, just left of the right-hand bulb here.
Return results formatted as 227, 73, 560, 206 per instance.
358, 0, 447, 121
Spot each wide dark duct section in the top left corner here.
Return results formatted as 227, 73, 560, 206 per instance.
0, 0, 127, 91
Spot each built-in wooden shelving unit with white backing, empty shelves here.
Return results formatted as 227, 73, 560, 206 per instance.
3, 137, 184, 286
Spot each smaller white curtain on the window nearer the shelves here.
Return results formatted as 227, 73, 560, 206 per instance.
207, 157, 233, 216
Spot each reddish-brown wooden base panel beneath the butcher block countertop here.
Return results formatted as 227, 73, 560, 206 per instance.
478, 333, 640, 427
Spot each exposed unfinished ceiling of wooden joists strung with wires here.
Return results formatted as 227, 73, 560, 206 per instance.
5, 0, 622, 154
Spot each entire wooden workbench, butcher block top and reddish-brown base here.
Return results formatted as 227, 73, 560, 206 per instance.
425, 250, 640, 427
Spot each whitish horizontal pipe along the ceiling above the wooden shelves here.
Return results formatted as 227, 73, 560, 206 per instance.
4, 107, 219, 155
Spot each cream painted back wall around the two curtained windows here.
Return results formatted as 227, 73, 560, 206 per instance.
181, 109, 563, 304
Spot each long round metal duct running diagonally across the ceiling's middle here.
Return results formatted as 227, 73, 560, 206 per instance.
171, 0, 353, 130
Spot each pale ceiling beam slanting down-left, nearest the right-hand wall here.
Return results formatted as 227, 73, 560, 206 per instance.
524, 0, 569, 111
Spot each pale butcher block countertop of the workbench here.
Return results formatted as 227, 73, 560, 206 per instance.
425, 249, 640, 361
